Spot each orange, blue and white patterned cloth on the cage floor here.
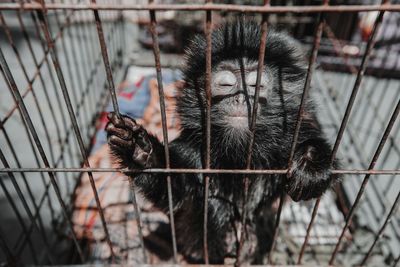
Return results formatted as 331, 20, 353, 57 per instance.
72, 67, 181, 264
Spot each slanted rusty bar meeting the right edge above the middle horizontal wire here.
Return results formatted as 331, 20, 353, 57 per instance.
329, 100, 400, 265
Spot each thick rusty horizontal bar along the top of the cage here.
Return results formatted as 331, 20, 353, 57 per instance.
0, 2, 400, 13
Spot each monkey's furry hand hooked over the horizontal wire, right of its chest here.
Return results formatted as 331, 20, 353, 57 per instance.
286, 139, 332, 201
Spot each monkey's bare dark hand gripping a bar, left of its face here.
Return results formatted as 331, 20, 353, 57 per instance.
106, 112, 153, 168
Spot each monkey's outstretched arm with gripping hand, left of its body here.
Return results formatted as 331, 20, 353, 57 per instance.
106, 113, 200, 211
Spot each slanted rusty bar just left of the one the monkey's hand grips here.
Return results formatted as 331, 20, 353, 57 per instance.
38, 0, 115, 261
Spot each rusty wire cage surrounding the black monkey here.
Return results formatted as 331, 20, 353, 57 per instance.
0, 0, 400, 266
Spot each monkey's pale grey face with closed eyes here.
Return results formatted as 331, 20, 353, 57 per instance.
211, 58, 274, 131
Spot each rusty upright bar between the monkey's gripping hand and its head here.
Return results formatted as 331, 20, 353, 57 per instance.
149, 0, 178, 263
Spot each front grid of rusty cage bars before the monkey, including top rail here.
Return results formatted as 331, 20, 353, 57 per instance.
0, 0, 400, 265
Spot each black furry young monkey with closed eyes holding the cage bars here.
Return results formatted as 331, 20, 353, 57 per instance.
106, 19, 337, 264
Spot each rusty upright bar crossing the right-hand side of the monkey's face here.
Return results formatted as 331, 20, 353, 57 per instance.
235, 0, 270, 266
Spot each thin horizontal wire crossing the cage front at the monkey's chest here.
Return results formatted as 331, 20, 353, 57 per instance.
0, 168, 400, 175
